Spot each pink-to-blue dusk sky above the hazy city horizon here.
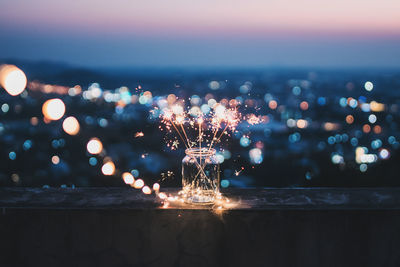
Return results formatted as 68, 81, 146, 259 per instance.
0, 0, 400, 67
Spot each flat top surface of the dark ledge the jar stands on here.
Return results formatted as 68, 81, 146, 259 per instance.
0, 187, 400, 210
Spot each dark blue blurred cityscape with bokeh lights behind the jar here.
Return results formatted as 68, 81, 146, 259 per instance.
0, 60, 400, 187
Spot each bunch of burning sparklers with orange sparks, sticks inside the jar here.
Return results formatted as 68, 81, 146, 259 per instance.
155, 101, 242, 202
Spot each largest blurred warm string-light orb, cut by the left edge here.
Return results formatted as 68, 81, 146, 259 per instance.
0, 65, 27, 96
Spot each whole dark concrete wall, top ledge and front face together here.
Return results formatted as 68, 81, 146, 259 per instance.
0, 188, 400, 267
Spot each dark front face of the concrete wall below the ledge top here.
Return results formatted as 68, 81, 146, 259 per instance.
0, 188, 400, 267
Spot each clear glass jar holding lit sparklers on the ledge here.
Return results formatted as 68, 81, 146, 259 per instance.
182, 147, 220, 204
